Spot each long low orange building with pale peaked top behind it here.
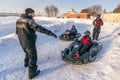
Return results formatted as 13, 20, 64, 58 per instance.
64, 8, 90, 19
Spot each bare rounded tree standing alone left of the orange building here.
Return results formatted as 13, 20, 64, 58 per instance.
45, 5, 59, 17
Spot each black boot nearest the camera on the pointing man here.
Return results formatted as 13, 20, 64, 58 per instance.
28, 66, 40, 79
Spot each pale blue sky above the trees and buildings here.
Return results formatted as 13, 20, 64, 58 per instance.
0, 0, 120, 13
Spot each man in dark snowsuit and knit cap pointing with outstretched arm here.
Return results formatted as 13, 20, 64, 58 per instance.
16, 8, 57, 79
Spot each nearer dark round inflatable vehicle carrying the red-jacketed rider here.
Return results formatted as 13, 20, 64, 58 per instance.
61, 41, 103, 64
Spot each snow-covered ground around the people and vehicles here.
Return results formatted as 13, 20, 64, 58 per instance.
0, 17, 120, 80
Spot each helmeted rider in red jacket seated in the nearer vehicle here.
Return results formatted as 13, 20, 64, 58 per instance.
75, 31, 92, 58
